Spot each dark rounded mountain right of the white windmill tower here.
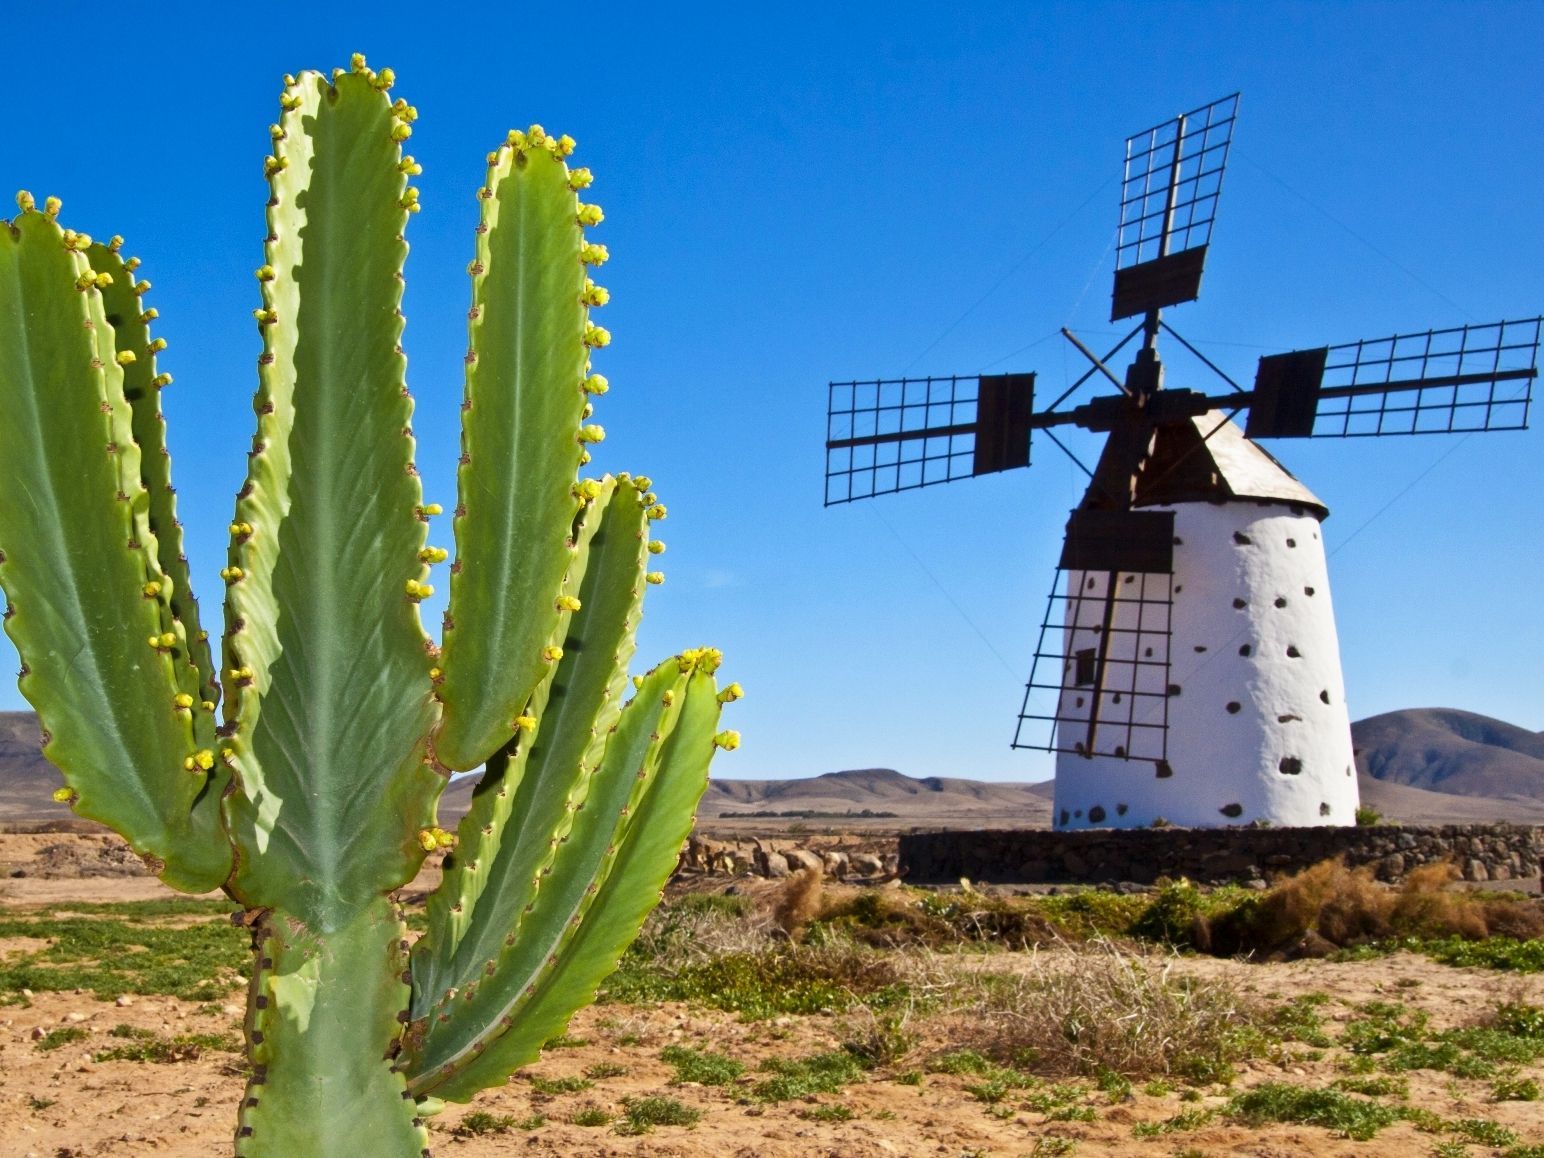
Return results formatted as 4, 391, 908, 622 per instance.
1351, 707, 1544, 800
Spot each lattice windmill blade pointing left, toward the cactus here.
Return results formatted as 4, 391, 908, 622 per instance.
826, 374, 1034, 506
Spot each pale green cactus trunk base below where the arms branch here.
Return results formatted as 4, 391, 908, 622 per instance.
236, 897, 429, 1158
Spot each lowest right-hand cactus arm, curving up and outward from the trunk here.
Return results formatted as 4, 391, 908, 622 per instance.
398, 653, 720, 1101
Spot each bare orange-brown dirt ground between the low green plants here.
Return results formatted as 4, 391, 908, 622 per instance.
0, 837, 1544, 1158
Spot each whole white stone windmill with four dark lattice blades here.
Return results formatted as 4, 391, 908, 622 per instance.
826, 93, 1544, 829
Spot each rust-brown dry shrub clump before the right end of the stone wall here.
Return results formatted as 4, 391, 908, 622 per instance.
1195, 860, 1544, 956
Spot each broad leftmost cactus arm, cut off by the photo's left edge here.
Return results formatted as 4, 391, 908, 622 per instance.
0, 208, 230, 891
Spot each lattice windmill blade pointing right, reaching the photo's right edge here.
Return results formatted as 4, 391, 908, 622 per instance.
1246, 318, 1544, 438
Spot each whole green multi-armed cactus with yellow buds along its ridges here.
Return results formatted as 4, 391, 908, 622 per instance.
0, 57, 738, 1158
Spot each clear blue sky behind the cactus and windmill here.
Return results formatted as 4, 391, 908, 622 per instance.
0, 3, 1544, 780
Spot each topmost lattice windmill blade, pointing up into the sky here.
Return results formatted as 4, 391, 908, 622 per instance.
1110, 93, 1238, 321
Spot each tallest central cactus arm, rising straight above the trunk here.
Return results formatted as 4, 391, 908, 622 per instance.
216, 73, 443, 931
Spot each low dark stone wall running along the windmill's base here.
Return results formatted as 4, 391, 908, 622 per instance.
900, 824, 1544, 885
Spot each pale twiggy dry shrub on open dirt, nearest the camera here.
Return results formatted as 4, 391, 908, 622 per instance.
954, 939, 1265, 1081
